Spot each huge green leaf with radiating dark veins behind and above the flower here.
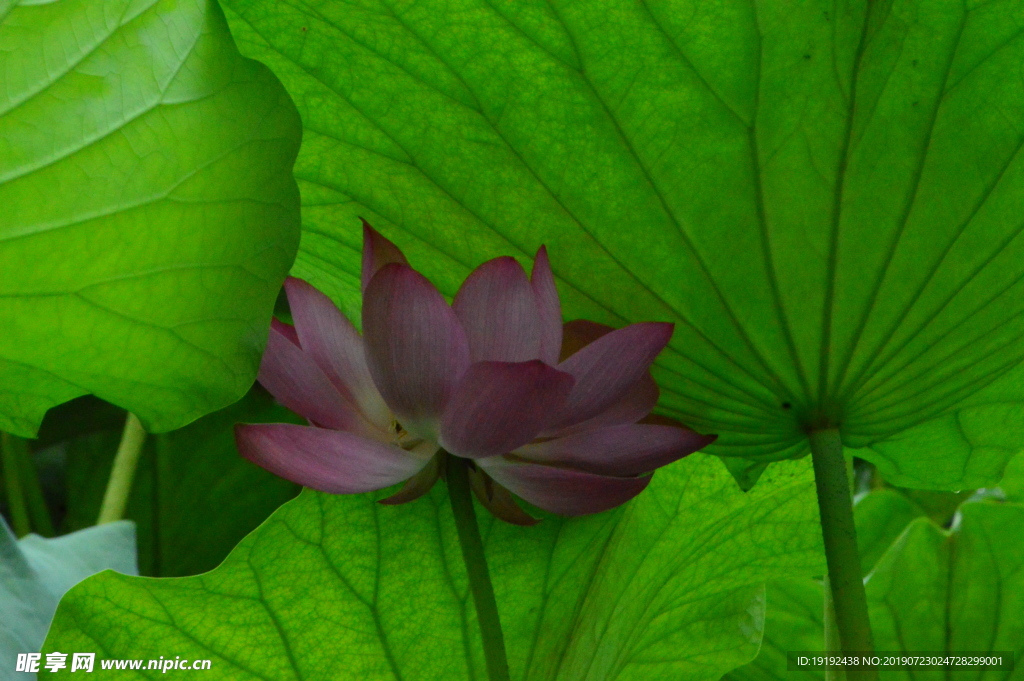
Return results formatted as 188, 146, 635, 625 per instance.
225, 0, 1024, 486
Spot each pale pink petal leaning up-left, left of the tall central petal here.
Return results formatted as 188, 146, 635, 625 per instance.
285, 276, 391, 430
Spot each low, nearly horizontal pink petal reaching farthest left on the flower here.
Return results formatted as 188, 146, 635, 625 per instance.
234, 423, 429, 495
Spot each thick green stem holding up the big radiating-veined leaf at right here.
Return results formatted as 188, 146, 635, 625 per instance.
809, 428, 878, 681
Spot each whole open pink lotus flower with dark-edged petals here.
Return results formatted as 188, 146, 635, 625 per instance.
236, 222, 715, 524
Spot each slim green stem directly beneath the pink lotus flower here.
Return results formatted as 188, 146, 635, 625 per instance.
445, 455, 510, 681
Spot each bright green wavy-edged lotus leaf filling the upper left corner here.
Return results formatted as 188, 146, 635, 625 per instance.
0, 0, 301, 435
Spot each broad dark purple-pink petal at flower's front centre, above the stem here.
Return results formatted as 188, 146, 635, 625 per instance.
440, 359, 572, 459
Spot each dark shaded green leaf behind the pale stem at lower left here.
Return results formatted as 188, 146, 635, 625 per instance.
62, 387, 305, 577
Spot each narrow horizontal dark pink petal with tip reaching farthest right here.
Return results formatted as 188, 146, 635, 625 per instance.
515, 424, 715, 475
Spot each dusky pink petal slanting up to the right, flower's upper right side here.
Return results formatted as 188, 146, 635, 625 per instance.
556, 322, 673, 427
